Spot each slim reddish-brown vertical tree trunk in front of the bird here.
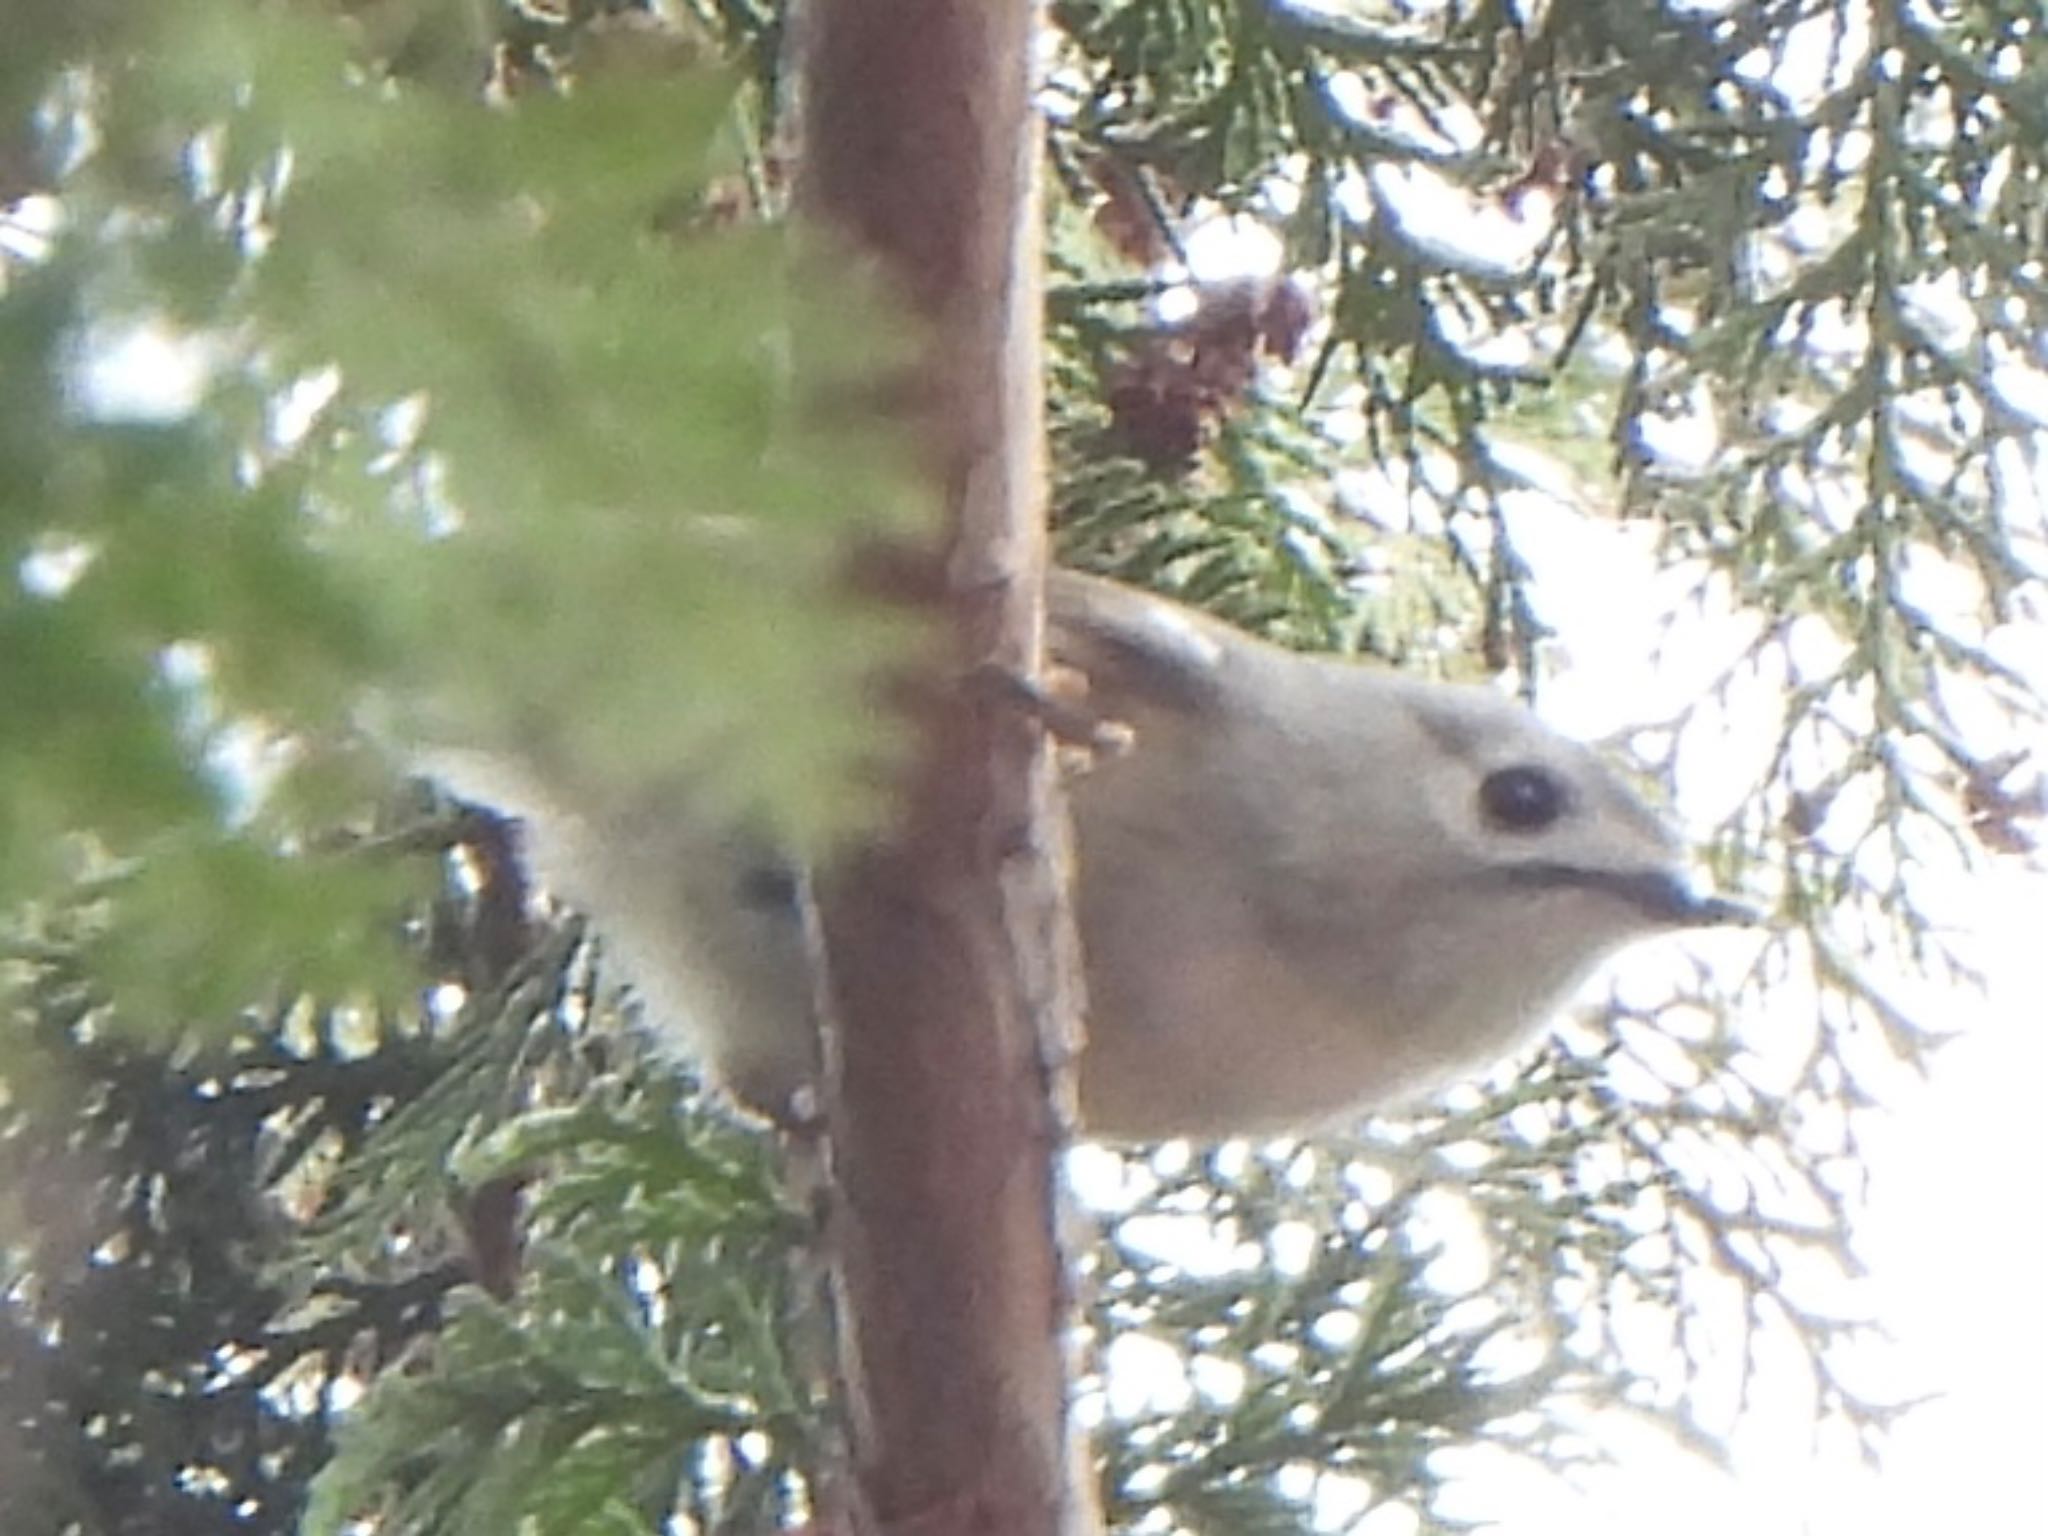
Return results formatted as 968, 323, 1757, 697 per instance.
803, 0, 1083, 1536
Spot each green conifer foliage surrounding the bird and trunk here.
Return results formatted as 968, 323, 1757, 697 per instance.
0, 0, 2048, 1536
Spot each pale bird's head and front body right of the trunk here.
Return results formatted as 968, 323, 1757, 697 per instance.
1049, 573, 1733, 1137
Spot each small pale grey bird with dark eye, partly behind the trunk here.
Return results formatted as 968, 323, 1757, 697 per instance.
424, 571, 1747, 1141
